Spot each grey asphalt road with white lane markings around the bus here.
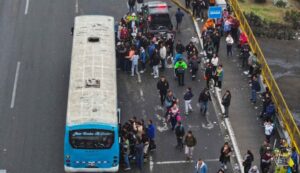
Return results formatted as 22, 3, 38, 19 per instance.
0, 0, 230, 173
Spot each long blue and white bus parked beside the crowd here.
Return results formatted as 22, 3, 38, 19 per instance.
64, 15, 119, 172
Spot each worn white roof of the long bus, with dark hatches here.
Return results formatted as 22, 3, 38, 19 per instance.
67, 15, 118, 126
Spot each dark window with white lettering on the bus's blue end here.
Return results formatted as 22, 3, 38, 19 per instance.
70, 129, 114, 149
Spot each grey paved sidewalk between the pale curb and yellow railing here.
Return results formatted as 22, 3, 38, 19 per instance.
173, 0, 282, 169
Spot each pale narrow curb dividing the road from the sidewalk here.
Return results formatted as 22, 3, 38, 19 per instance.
171, 0, 244, 173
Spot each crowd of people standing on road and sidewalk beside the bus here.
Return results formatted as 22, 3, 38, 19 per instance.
116, 0, 298, 173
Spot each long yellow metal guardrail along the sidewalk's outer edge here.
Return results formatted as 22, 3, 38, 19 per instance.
228, 0, 300, 153
